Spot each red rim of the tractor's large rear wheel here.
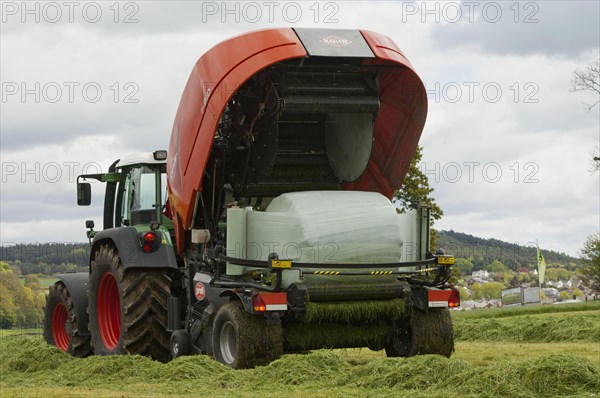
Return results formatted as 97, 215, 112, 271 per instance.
98, 272, 121, 350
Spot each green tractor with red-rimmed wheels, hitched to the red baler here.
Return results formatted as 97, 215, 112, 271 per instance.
44, 151, 177, 361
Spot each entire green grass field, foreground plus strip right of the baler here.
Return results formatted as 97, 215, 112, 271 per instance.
0, 303, 600, 397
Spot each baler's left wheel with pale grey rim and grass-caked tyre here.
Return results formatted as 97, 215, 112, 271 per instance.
212, 302, 283, 369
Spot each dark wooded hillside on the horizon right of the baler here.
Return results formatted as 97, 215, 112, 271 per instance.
437, 231, 580, 270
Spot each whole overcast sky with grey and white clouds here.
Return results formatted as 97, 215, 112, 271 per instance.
0, 1, 600, 255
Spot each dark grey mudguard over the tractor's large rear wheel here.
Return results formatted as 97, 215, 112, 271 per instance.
90, 227, 177, 272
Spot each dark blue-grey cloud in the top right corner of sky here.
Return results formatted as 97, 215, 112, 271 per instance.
432, 1, 600, 57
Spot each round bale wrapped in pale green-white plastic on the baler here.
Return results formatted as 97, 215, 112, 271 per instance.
246, 191, 402, 263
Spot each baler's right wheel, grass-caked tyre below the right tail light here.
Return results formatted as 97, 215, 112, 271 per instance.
385, 308, 454, 358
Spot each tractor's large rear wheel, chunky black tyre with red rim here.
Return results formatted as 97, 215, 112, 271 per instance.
88, 245, 171, 362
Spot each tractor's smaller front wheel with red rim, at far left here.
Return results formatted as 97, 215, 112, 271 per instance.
44, 282, 92, 358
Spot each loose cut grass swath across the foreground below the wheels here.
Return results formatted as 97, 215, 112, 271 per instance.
0, 338, 600, 397
